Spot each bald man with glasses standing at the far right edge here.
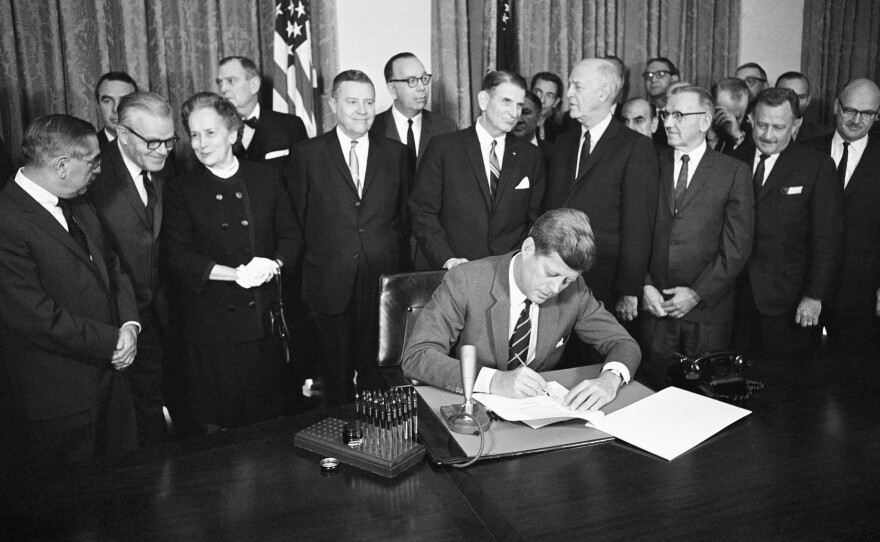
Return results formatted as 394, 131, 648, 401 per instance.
806, 79, 880, 352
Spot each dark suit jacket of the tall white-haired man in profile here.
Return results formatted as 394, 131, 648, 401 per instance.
547, 119, 659, 308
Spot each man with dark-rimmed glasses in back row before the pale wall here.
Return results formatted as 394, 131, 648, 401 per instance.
370, 53, 457, 171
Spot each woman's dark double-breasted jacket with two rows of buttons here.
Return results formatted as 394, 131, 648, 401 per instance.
162, 160, 300, 344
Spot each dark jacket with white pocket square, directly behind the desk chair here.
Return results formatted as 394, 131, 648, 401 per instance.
409, 126, 545, 269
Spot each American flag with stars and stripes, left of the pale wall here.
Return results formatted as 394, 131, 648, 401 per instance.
272, 0, 318, 137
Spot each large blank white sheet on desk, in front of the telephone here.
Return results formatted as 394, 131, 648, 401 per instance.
591, 387, 751, 461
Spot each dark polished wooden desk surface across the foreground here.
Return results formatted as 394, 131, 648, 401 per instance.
0, 358, 880, 541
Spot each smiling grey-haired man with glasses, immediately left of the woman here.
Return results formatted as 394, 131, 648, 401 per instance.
89, 92, 179, 446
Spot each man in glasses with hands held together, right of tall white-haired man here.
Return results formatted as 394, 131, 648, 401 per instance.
642, 87, 754, 386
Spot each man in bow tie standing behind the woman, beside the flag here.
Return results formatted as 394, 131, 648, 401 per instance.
217, 56, 309, 173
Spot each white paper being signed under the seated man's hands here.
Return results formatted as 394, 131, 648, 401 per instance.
474, 382, 605, 429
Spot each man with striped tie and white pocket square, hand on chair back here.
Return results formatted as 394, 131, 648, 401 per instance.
409, 71, 545, 269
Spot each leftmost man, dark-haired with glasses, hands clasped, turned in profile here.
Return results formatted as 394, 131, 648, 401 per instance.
0, 115, 140, 463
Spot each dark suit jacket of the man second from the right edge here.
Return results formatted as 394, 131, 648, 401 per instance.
735, 142, 843, 316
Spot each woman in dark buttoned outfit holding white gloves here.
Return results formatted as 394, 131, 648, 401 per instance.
163, 92, 300, 431
